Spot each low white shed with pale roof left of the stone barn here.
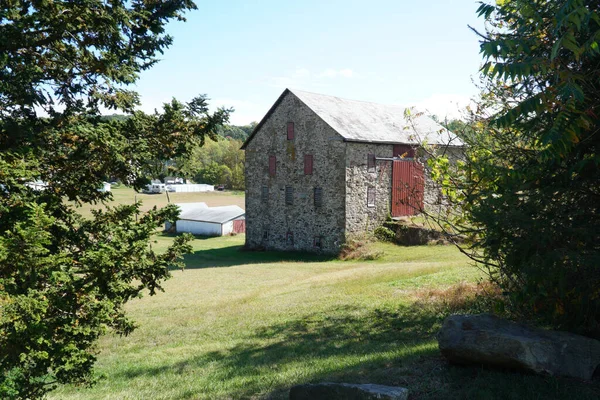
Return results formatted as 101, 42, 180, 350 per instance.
165, 203, 246, 236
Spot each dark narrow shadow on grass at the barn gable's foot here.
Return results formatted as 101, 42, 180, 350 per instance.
178, 245, 336, 269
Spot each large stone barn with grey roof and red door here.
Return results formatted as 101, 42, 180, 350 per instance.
242, 89, 462, 253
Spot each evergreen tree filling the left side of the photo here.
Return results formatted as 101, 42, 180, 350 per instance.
0, 0, 230, 399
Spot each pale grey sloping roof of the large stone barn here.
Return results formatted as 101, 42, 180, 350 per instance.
290, 90, 463, 146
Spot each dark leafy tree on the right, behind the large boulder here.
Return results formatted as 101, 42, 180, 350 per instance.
432, 0, 600, 337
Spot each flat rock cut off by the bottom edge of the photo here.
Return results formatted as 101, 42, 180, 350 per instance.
290, 382, 408, 400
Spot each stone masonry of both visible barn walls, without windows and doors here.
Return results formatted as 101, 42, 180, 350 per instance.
245, 92, 460, 253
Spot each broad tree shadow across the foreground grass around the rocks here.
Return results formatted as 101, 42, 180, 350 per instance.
109, 307, 600, 399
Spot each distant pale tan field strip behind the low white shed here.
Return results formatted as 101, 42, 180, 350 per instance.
71, 185, 246, 217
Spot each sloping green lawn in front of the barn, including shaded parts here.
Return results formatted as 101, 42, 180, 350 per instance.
50, 235, 600, 399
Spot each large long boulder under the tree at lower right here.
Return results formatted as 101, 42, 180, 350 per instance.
438, 314, 600, 380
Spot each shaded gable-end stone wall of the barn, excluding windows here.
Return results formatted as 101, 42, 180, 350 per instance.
246, 93, 346, 253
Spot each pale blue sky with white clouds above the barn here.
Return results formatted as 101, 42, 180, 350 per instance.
137, 0, 483, 124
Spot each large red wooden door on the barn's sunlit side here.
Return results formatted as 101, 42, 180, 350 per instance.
392, 161, 425, 217
